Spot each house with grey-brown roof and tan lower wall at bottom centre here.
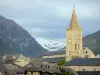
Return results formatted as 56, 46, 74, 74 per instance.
23, 62, 60, 75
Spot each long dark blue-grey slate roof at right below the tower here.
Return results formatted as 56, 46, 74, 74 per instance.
65, 58, 100, 66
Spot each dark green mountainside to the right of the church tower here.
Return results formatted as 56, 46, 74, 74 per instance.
83, 30, 100, 55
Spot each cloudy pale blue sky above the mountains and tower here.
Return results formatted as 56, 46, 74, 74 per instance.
0, 0, 100, 40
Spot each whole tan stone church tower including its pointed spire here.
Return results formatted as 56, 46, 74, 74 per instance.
66, 9, 83, 61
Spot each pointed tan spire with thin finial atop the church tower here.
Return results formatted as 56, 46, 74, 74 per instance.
70, 3, 79, 29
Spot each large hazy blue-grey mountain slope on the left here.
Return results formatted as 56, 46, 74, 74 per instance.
0, 15, 47, 56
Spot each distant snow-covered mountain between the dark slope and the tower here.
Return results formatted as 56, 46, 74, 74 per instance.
35, 37, 65, 51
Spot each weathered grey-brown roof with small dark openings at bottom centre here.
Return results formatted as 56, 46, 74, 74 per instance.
23, 62, 60, 73
